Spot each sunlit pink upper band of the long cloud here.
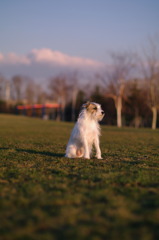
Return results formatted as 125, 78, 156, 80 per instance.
0, 48, 102, 68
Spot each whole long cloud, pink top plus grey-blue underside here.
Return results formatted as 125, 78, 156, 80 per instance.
0, 48, 105, 82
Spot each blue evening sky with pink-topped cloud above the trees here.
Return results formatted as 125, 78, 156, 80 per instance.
0, 0, 159, 80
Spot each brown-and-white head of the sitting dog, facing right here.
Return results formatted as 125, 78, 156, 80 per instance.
82, 102, 105, 121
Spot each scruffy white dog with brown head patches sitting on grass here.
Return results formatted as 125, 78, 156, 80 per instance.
65, 102, 104, 159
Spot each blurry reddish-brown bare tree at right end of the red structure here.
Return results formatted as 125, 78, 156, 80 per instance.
49, 75, 69, 121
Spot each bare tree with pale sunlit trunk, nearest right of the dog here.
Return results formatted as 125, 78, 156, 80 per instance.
101, 53, 135, 127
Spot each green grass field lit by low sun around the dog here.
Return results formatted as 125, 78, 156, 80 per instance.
0, 115, 159, 240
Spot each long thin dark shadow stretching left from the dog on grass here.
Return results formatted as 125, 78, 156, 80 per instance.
0, 148, 64, 158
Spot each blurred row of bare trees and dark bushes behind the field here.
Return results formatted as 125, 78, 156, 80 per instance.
0, 36, 159, 129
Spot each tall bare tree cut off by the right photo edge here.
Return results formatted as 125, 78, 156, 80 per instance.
142, 38, 159, 129
